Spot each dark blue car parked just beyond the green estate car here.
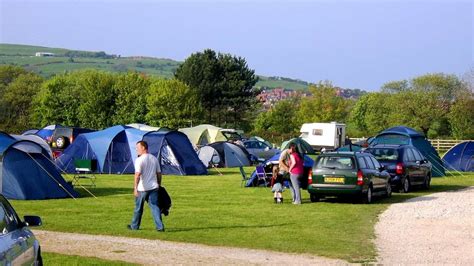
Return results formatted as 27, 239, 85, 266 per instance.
366, 144, 431, 193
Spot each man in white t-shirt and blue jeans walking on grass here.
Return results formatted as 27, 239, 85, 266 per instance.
127, 141, 165, 232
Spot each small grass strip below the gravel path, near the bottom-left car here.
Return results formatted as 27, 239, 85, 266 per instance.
42, 252, 138, 266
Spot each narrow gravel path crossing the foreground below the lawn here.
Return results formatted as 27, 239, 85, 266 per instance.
33, 230, 347, 265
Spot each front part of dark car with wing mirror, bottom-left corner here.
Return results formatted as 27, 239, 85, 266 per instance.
0, 194, 43, 265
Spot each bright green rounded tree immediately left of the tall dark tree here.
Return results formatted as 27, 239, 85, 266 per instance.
146, 79, 202, 128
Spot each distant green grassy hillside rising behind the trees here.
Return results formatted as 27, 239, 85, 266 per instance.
0, 43, 308, 90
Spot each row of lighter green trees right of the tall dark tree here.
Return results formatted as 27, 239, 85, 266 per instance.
254, 70, 474, 142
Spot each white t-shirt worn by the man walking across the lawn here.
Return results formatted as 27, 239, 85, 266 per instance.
135, 153, 161, 191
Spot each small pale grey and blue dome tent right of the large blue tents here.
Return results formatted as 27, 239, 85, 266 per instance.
198, 141, 250, 167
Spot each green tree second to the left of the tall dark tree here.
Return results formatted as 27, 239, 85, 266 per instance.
112, 72, 151, 124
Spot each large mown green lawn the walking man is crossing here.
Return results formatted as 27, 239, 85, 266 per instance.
12, 167, 474, 262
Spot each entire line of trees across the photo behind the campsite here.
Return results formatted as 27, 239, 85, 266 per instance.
0, 49, 474, 143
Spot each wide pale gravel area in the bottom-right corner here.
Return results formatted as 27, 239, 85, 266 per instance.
375, 187, 474, 265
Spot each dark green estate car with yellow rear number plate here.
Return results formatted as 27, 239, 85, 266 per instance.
308, 152, 392, 203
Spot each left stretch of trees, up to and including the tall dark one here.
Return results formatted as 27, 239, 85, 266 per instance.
0, 50, 259, 133
